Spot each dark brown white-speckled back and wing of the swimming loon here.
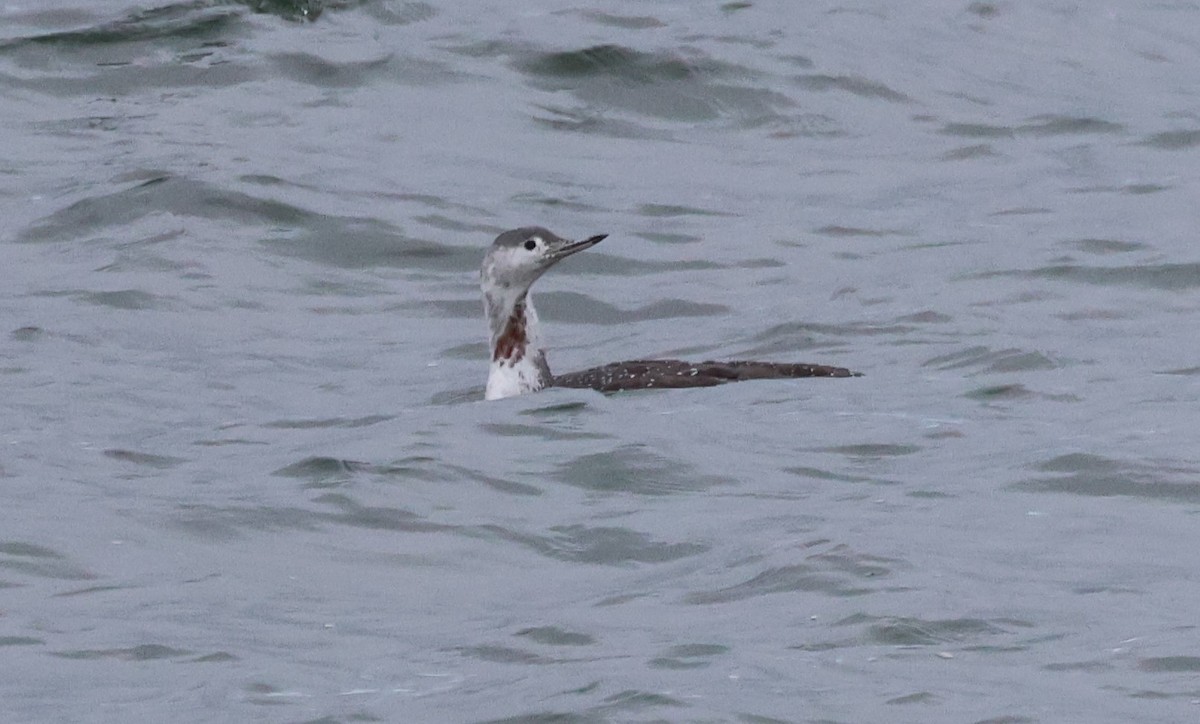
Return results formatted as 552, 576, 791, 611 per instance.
553, 359, 860, 393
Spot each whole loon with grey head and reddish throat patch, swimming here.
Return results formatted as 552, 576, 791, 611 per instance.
480, 226, 860, 400
